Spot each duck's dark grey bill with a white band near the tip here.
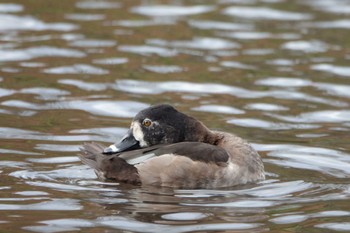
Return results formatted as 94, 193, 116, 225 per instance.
103, 130, 141, 154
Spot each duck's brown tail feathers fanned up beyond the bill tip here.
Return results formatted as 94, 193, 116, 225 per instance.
79, 142, 104, 170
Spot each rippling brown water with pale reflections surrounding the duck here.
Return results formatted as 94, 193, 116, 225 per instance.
0, 0, 350, 232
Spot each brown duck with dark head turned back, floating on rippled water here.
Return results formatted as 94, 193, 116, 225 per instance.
79, 104, 265, 189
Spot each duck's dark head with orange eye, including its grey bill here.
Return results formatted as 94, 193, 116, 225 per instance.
103, 104, 201, 154
